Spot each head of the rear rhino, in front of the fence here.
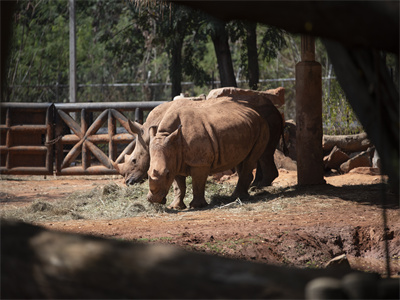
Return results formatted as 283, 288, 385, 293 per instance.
118, 120, 150, 185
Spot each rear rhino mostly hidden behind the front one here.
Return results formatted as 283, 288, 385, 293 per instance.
114, 88, 284, 193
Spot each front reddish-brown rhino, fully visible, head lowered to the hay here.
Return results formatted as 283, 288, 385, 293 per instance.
147, 97, 269, 208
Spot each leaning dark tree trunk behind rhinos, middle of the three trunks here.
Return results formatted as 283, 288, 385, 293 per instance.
211, 21, 237, 87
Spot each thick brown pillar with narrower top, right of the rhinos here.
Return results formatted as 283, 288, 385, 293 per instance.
296, 35, 325, 185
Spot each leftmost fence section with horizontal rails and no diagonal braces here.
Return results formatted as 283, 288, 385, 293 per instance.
0, 103, 54, 175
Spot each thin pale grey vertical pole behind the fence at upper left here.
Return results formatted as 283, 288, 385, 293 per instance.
69, 0, 76, 102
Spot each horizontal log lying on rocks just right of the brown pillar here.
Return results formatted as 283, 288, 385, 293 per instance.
322, 132, 372, 153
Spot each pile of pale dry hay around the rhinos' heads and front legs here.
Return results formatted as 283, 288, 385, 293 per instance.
1, 177, 241, 223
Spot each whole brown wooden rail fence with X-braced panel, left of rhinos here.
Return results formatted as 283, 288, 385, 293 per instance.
0, 102, 163, 175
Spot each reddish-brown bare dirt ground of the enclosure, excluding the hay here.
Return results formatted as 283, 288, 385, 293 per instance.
0, 169, 400, 276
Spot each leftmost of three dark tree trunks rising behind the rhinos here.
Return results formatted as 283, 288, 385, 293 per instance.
169, 38, 183, 99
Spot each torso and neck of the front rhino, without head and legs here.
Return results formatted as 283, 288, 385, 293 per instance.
158, 100, 267, 172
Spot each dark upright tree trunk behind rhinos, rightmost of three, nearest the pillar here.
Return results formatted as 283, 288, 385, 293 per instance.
246, 23, 259, 90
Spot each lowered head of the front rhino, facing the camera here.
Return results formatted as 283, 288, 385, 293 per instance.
147, 126, 181, 204
